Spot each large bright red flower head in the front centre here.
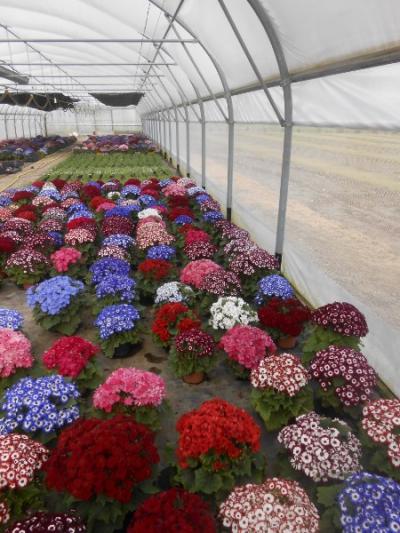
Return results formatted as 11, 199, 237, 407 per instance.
176, 398, 261, 470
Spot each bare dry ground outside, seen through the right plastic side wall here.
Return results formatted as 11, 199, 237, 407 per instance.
189, 125, 400, 328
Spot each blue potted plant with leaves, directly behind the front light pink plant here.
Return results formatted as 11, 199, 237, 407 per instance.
94, 304, 142, 358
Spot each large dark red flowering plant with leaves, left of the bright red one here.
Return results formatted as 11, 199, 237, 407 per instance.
43, 415, 159, 533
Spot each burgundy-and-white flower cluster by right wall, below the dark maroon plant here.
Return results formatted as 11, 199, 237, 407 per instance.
310, 346, 377, 407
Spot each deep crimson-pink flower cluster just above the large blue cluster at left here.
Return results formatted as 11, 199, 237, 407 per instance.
42, 336, 99, 378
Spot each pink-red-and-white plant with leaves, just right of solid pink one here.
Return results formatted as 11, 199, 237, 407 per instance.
251, 354, 314, 431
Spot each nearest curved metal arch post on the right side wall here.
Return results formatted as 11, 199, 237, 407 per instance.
247, 0, 293, 265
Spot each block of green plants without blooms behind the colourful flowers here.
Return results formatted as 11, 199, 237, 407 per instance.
44, 152, 170, 183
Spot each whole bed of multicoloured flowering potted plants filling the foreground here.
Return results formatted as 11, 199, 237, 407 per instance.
0, 159, 400, 533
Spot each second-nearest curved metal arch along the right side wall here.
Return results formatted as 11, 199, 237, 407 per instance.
149, 0, 235, 216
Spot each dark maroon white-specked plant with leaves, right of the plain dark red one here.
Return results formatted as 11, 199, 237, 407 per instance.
303, 302, 368, 365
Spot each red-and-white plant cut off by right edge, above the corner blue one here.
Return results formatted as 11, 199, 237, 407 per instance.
361, 398, 400, 481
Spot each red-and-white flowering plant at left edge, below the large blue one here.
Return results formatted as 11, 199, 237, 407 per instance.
0, 433, 49, 524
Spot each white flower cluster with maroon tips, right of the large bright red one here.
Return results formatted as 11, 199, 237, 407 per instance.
278, 412, 361, 483
